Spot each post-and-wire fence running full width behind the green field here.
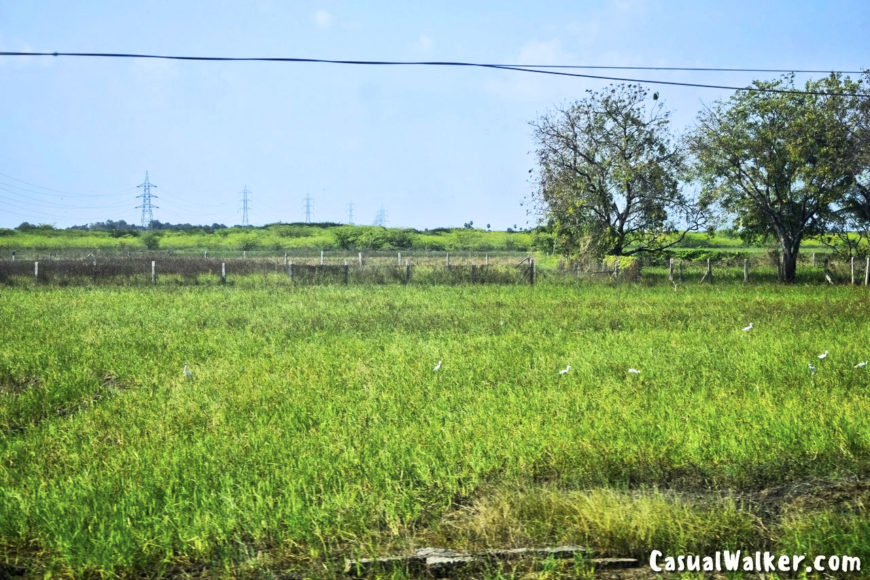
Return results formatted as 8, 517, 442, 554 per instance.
0, 253, 870, 289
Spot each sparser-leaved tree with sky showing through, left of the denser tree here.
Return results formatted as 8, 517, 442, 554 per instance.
532, 84, 701, 255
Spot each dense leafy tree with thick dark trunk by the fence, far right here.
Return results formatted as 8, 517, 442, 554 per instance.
688, 75, 861, 282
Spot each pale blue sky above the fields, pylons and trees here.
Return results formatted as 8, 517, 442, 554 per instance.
0, 0, 870, 229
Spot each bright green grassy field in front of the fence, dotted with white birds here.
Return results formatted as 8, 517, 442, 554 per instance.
0, 283, 870, 577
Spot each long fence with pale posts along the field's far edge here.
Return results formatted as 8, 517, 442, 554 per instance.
0, 252, 870, 288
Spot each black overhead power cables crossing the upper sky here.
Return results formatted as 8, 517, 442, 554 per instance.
0, 51, 870, 97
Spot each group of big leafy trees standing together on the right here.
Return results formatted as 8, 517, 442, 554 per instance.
532, 71, 870, 282
